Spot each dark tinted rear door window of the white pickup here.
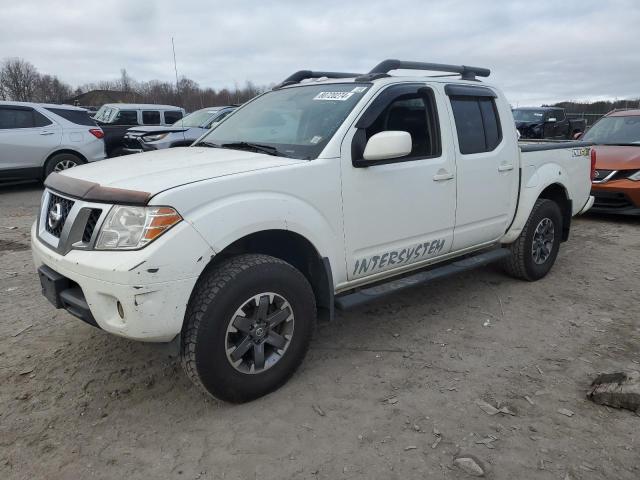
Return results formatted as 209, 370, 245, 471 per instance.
451, 96, 502, 155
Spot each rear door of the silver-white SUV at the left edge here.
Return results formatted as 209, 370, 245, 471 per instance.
0, 106, 62, 170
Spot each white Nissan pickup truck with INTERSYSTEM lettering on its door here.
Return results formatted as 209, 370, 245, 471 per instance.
31, 60, 594, 402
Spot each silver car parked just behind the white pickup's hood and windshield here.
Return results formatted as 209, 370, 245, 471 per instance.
123, 106, 236, 154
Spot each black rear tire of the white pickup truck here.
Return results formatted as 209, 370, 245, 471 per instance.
502, 198, 562, 282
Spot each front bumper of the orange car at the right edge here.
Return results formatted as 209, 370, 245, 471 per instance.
590, 179, 640, 215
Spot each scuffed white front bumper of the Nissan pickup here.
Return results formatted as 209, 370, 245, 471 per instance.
31, 222, 213, 342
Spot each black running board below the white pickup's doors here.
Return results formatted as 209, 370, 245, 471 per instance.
335, 248, 511, 310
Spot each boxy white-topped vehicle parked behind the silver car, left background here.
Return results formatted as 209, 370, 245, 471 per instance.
93, 103, 185, 157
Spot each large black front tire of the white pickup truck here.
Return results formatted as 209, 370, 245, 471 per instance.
181, 254, 316, 403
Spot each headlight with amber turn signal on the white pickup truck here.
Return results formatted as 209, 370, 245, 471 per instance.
95, 205, 182, 250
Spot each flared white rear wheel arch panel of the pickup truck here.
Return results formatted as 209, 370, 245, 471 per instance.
500, 163, 571, 243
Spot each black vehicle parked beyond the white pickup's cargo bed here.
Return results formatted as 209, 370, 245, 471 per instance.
513, 107, 587, 140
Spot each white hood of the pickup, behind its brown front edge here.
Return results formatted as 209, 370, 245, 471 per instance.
61, 147, 306, 196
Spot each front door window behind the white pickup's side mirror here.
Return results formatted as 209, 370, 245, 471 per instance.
366, 93, 440, 160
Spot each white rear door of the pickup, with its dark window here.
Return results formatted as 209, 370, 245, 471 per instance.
445, 85, 519, 251
